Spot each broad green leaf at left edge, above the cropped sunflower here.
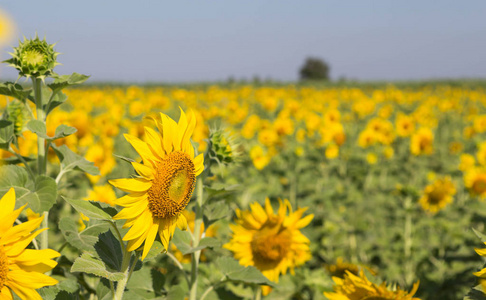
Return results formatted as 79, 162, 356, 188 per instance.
0, 165, 57, 213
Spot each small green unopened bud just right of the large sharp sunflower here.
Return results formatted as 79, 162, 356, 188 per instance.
209, 129, 241, 165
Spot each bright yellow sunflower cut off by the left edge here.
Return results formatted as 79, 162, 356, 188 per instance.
0, 188, 60, 300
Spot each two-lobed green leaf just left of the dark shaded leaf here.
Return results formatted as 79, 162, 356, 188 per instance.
59, 217, 110, 252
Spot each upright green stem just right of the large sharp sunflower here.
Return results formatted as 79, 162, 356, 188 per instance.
189, 178, 203, 300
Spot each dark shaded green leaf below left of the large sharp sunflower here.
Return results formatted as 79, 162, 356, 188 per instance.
95, 231, 123, 270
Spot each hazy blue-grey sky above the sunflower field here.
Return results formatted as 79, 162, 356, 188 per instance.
0, 0, 486, 82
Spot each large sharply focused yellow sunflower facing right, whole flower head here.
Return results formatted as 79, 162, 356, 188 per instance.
109, 109, 204, 260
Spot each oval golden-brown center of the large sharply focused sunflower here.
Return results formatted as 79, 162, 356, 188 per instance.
148, 151, 196, 218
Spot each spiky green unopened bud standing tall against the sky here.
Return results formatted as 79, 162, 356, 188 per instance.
4, 36, 59, 79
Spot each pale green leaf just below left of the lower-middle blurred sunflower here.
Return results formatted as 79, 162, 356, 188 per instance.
216, 257, 275, 286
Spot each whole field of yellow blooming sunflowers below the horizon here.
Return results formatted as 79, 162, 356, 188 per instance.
0, 37, 486, 300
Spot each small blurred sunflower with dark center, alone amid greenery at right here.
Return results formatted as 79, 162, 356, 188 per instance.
419, 177, 456, 213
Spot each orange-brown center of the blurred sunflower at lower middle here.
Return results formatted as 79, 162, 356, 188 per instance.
251, 220, 292, 264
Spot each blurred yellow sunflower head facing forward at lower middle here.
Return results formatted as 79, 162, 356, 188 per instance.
223, 198, 314, 295
